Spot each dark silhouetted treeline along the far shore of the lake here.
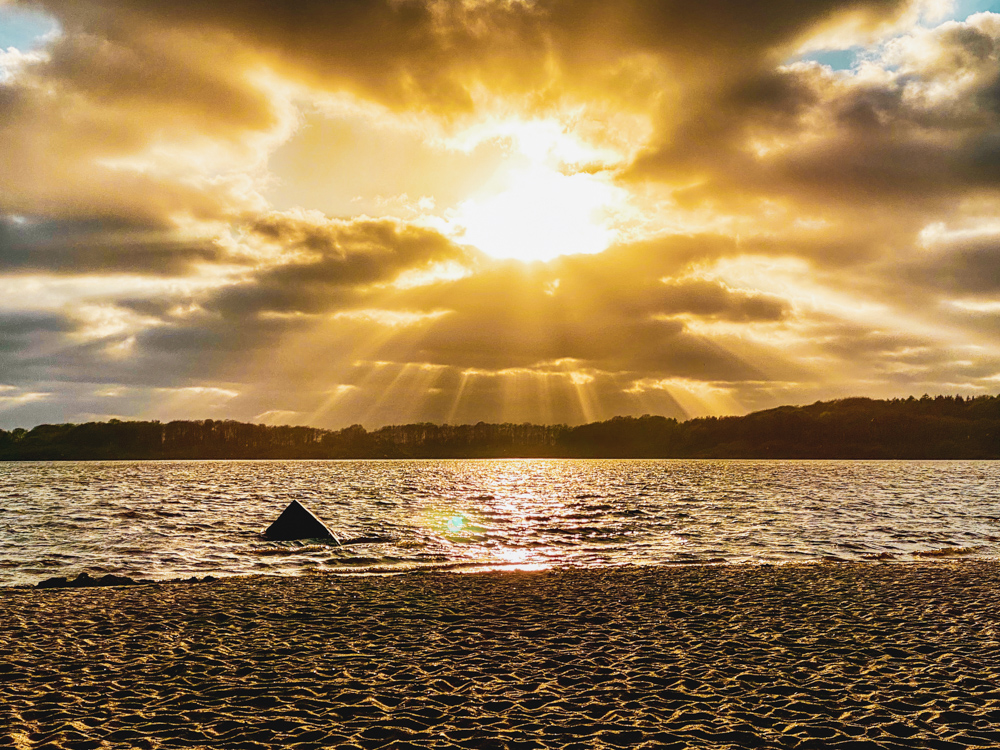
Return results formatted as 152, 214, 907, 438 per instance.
0, 396, 1000, 461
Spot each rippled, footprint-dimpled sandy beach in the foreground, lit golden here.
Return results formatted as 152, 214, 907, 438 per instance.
0, 561, 1000, 750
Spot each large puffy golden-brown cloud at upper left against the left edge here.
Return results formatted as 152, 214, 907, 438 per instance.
0, 9, 294, 225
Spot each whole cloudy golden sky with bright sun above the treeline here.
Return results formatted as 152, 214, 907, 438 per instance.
0, 0, 1000, 429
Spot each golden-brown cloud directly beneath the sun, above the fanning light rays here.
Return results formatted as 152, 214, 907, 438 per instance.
376, 249, 786, 380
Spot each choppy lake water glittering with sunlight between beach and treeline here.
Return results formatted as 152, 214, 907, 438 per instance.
0, 459, 1000, 586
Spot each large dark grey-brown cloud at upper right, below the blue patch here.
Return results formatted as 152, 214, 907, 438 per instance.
632, 11, 1000, 215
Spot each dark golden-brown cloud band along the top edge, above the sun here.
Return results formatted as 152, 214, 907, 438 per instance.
21, 0, 910, 109
